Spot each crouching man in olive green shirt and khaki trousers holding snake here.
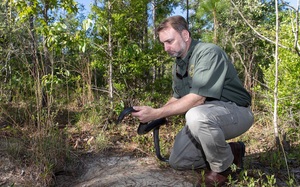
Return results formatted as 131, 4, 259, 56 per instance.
132, 16, 253, 186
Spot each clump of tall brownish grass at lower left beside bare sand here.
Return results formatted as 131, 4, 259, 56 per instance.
0, 124, 70, 186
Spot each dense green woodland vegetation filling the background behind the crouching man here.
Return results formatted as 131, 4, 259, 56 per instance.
0, 0, 300, 186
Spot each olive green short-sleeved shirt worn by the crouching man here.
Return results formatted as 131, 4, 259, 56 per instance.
172, 40, 251, 106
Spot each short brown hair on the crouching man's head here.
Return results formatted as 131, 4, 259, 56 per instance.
156, 16, 191, 35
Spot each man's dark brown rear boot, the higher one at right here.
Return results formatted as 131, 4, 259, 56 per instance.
229, 142, 245, 169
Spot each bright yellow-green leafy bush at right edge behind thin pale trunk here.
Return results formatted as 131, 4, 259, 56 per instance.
263, 24, 300, 125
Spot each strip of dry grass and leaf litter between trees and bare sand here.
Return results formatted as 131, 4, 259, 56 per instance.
0, 103, 300, 186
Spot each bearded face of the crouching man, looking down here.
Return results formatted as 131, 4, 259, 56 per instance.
158, 27, 187, 58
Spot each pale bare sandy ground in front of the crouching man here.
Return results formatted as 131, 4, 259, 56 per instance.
56, 155, 197, 187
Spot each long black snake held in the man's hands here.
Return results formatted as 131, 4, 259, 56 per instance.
117, 107, 168, 162
